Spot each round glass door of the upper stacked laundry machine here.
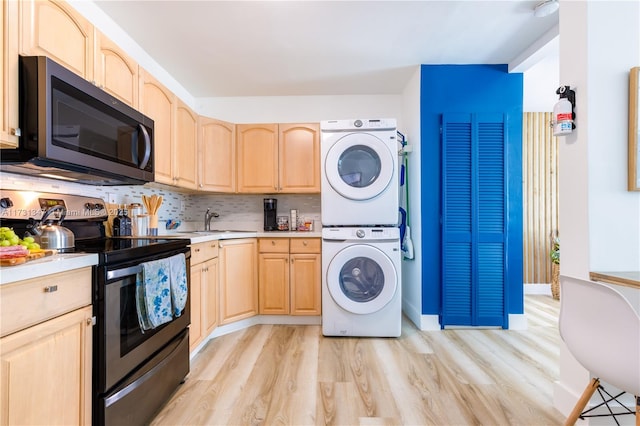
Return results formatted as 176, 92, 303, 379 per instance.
324, 133, 394, 200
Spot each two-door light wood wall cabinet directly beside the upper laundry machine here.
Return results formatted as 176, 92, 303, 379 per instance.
236, 120, 320, 193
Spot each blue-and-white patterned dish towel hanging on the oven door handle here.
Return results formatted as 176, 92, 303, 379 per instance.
136, 253, 188, 332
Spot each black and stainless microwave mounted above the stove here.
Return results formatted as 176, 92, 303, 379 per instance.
0, 56, 154, 185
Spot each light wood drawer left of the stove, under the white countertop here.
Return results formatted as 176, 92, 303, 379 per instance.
0, 268, 91, 336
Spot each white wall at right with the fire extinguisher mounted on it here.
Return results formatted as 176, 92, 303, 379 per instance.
554, 1, 640, 420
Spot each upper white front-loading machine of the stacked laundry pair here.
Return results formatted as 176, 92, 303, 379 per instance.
320, 118, 399, 226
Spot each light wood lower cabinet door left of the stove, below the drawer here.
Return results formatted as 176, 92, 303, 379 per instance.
0, 306, 93, 425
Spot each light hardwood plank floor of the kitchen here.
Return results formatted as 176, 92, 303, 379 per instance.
152, 295, 564, 425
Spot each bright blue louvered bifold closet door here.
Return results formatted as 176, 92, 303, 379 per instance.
440, 114, 508, 328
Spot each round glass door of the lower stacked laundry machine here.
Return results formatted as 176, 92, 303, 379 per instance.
326, 244, 398, 314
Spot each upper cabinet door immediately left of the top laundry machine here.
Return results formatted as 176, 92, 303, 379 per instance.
279, 123, 320, 193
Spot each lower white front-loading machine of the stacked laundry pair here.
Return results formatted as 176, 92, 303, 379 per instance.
322, 227, 402, 337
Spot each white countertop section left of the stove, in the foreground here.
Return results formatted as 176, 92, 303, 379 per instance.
0, 253, 98, 285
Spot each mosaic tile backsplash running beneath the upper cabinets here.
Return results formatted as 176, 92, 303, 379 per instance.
0, 173, 320, 231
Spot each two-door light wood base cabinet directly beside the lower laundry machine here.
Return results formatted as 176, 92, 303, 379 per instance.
258, 238, 322, 315
